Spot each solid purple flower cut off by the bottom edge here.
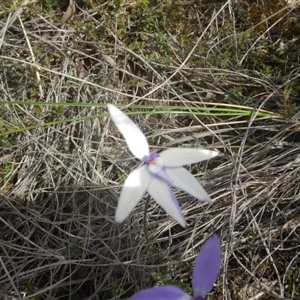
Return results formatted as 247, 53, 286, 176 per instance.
130, 235, 221, 300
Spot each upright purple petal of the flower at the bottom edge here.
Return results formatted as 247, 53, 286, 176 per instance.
193, 235, 221, 297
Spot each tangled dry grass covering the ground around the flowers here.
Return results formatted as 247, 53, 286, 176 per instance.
0, 1, 300, 300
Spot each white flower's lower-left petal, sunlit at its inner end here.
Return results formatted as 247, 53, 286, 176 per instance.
115, 165, 150, 223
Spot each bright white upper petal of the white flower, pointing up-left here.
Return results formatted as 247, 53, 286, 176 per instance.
107, 103, 149, 160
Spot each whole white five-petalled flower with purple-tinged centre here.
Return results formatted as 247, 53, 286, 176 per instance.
107, 104, 219, 227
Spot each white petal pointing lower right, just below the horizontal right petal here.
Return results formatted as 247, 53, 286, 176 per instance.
165, 167, 211, 202
